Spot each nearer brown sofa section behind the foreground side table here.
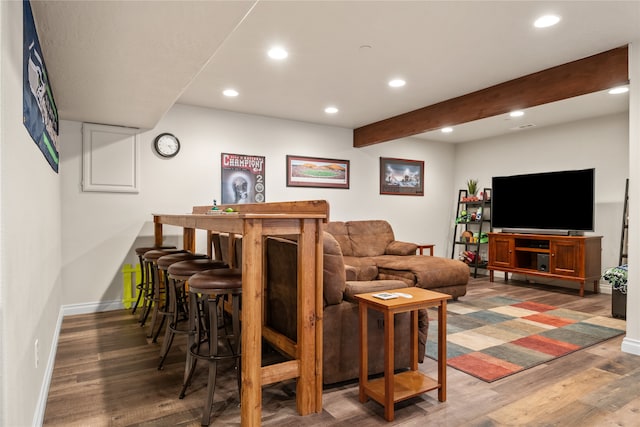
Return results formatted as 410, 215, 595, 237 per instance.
265, 232, 428, 384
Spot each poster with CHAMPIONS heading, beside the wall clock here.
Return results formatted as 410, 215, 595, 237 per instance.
222, 153, 265, 205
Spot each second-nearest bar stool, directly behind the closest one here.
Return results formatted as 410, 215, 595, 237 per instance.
158, 255, 228, 370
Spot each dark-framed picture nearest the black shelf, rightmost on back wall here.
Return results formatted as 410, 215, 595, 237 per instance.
380, 157, 424, 196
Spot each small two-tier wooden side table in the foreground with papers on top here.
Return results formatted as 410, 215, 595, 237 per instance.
355, 287, 451, 421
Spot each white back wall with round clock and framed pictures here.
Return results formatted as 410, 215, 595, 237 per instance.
60, 105, 455, 311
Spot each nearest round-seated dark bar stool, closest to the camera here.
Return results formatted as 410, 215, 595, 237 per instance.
179, 269, 242, 425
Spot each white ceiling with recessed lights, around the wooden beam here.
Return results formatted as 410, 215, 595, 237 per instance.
31, 0, 640, 142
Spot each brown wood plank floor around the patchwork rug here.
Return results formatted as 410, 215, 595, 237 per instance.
44, 278, 640, 427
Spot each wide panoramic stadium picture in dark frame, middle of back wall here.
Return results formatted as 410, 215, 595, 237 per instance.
287, 155, 349, 188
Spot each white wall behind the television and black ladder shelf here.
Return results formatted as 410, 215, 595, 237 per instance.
454, 113, 629, 286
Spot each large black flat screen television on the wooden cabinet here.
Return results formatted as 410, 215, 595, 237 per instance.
491, 169, 595, 234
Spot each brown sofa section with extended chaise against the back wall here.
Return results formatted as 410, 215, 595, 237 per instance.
325, 220, 469, 299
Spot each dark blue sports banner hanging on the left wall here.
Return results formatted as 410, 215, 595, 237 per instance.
22, 0, 60, 172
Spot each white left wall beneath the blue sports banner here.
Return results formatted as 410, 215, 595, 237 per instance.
0, 1, 62, 426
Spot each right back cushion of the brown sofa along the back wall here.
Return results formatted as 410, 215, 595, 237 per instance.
345, 220, 395, 257
